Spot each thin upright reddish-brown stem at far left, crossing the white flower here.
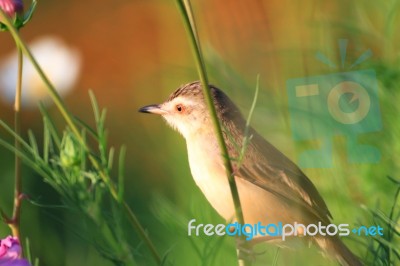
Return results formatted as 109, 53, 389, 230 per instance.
9, 44, 23, 243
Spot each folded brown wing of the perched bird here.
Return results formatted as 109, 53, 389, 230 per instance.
236, 132, 332, 223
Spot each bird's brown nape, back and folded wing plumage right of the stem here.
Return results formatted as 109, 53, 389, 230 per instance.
211, 86, 332, 223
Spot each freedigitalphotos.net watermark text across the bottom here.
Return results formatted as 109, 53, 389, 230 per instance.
188, 219, 383, 241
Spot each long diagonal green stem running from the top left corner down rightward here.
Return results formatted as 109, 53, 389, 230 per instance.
0, 9, 161, 264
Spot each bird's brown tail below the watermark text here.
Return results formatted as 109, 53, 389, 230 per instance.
315, 237, 363, 266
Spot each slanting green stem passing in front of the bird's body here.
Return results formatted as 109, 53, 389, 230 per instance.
176, 0, 248, 265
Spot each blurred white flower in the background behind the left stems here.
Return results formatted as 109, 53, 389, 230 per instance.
0, 36, 81, 107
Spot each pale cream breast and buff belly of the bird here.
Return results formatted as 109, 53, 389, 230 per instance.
187, 134, 296, 224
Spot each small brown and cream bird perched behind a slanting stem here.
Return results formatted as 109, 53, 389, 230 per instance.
139, 81, 363, 266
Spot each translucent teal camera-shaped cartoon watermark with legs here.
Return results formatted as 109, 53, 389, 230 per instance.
286, 40, 382, 168
